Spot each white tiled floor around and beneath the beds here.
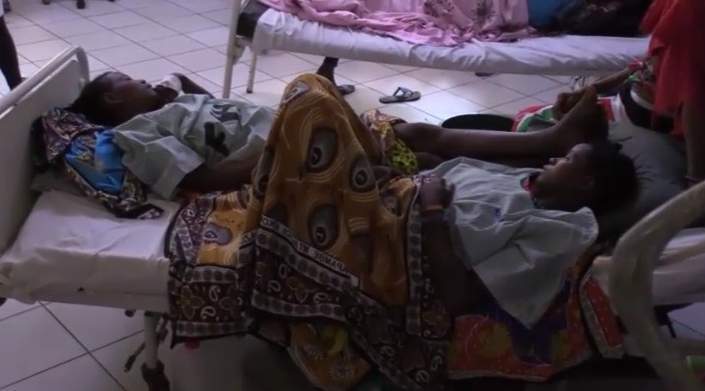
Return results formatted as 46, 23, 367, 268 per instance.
0, 0, 705, 391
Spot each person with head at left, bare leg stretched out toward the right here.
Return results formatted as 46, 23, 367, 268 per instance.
70, 68, 606, 198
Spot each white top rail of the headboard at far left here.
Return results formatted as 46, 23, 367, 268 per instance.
0, 46, 89, 113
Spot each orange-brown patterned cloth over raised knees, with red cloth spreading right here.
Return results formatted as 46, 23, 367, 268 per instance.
167, 75, 621, 390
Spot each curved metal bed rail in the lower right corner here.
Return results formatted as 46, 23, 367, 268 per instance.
609, 182, 705, 391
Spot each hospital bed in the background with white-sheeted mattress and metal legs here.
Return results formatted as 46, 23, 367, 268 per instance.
223, 0, 648, 98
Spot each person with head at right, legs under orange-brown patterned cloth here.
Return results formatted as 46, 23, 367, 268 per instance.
168, 75, 636, 389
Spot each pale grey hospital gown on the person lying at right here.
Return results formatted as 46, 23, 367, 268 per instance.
430, 158, 598, 327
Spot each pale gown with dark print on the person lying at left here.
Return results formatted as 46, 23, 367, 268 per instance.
115, 94, 275, 199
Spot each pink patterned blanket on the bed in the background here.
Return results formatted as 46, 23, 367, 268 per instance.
259, 0, 533, 46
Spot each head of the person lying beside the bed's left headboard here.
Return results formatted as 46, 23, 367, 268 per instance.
69, 72, 162, 126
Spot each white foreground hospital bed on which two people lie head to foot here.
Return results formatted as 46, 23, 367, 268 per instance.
0, 47, 705, 391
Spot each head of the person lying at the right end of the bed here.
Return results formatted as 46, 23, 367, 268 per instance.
532, 141, 638, 214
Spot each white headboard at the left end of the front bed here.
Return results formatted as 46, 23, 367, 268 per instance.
0, 47, 89, 254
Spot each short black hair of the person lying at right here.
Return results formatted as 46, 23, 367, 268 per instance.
588, 141, 639, 214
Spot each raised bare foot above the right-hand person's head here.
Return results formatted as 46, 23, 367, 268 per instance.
551, 87, 609, 154
